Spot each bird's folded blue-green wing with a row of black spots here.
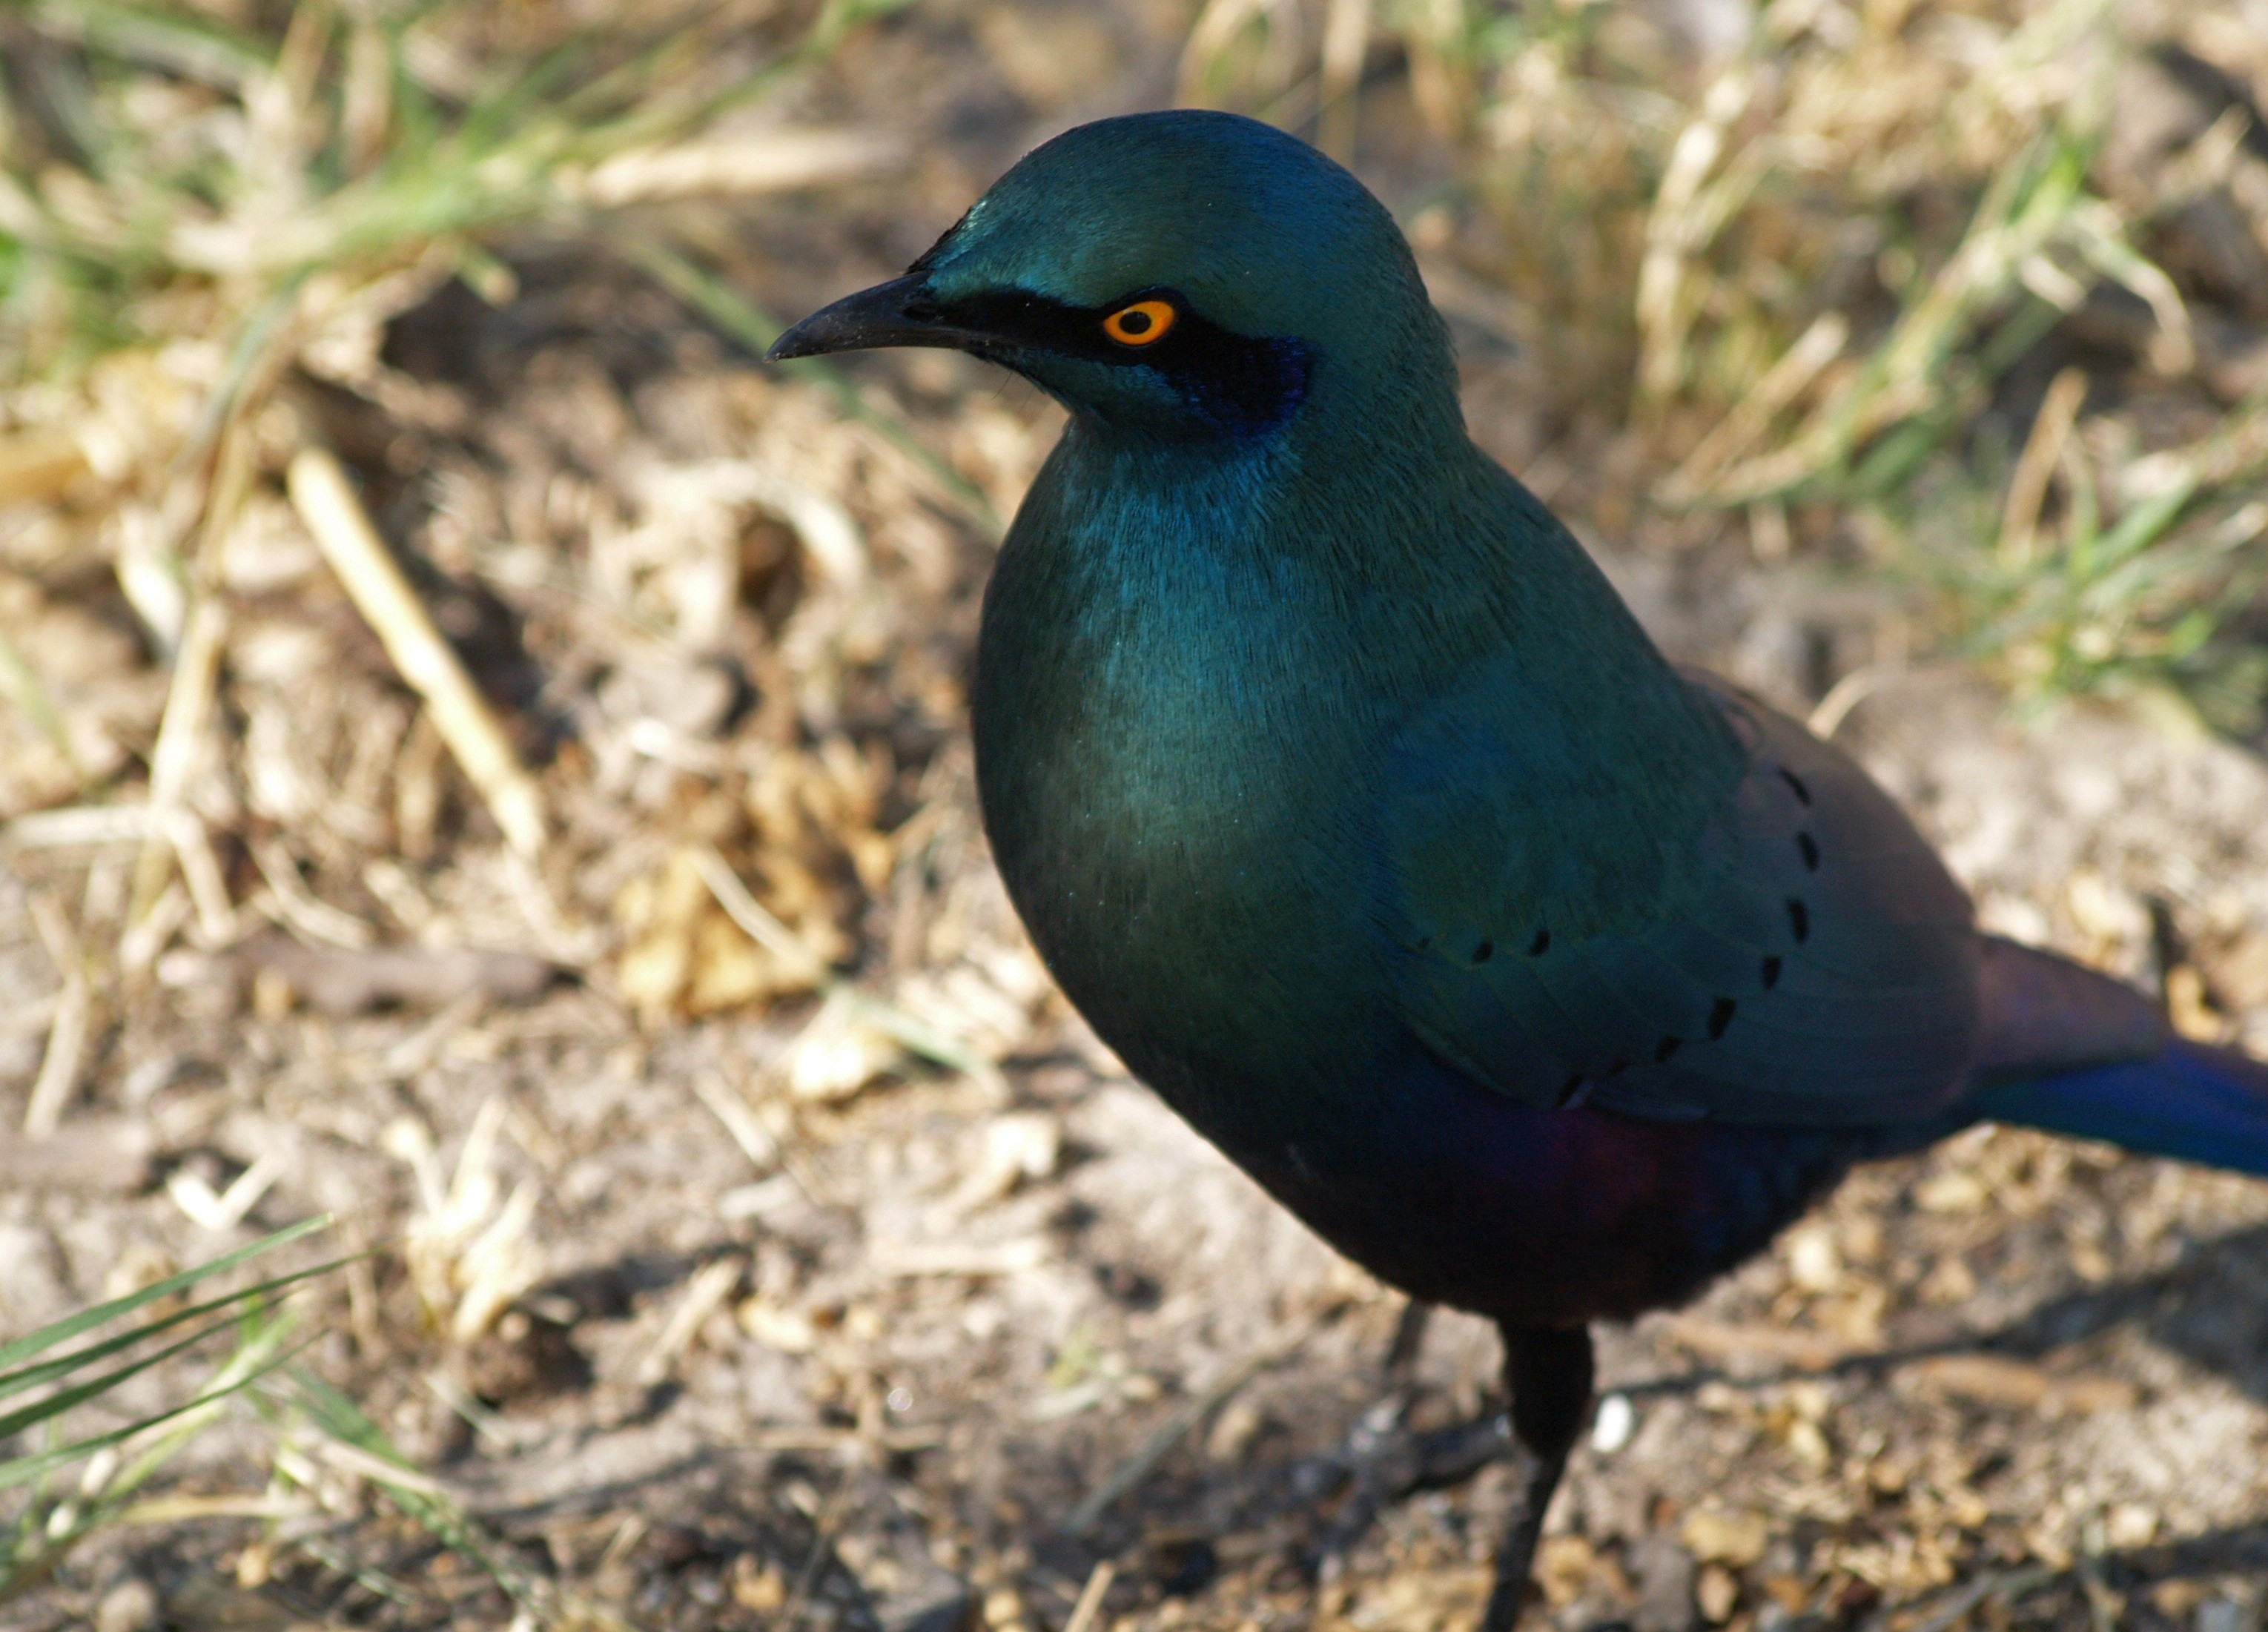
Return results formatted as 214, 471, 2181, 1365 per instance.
1383, 675, 1980, 1124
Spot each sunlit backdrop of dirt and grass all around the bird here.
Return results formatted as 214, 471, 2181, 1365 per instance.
0, 0, 2268, 1632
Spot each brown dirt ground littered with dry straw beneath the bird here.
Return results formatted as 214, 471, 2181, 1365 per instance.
0, 4, 2268, 1632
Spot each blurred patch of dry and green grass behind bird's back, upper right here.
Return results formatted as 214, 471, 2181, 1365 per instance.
1184, 0, 2268, 732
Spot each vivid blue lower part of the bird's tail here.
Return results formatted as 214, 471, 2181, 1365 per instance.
1962, 1038, 2268, 1177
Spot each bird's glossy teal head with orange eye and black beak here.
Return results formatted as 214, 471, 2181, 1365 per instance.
771, 111, 1456, 442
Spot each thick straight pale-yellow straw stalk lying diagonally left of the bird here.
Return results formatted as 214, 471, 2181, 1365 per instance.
285, 446, 544, 857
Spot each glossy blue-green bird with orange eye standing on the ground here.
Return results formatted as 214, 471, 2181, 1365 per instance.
769, 109, 2268, 1632
